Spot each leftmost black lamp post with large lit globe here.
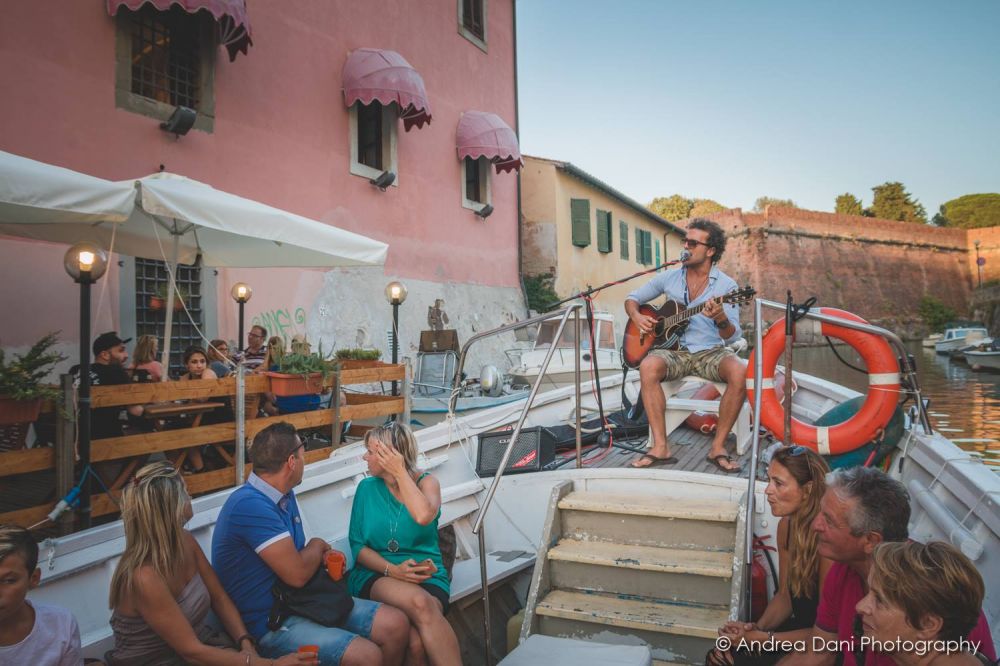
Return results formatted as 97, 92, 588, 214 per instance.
63, 241, 108, 529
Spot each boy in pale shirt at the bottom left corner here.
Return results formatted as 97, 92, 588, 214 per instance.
0, 525, 83, 666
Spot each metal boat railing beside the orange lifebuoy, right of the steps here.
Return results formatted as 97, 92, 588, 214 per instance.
741, 298, 931, 618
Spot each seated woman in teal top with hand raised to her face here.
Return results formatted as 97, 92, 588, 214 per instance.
347, 423, 462, 666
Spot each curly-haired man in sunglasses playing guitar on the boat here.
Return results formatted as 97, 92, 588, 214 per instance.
625, 219, 746, 472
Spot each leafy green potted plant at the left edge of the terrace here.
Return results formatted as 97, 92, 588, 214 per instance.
0, 333, 66, 436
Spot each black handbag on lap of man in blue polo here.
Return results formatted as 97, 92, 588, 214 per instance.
267, 566, 354, 631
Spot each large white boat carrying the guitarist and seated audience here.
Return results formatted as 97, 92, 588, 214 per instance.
32, 308, 1000, 666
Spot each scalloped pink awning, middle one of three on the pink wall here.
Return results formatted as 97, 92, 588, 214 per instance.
343, 49, 431, 132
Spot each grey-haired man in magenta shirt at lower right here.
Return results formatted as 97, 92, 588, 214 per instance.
780, 467, 996, 666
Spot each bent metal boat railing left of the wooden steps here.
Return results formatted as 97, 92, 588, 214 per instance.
448, 303, 583, 666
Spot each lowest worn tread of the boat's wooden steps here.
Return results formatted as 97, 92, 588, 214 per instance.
535, 590, 729, 640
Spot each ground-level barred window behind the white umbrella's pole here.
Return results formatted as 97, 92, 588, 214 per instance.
135, 258, 204, 377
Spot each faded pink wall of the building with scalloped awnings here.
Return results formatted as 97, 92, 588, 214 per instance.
0, 0, 518, 346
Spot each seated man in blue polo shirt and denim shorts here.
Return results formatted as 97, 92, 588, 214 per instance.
212, 423, 410, 666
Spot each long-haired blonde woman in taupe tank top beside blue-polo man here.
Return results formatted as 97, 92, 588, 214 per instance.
106, 462, 316, 666
